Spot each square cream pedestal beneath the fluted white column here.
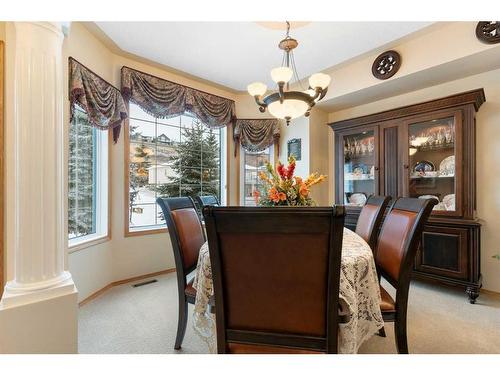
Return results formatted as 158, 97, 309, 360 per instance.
0, 277, 78, 353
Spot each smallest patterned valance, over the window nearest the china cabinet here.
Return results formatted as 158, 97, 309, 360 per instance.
233, 119, 280, 156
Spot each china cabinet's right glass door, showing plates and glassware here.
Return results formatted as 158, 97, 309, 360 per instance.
405, 114, 461, 215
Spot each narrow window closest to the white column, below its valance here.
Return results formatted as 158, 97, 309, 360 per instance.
68, 107, 108, 246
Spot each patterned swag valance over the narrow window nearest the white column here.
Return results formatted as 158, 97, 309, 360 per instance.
69, 57, 128, 143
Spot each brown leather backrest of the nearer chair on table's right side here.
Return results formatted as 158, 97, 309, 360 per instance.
375, 198, 436, 290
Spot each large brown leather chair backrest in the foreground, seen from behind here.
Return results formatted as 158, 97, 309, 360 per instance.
203, 206, 344, 353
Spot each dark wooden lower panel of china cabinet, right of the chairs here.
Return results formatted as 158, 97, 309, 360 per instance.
415, 225, 469, 280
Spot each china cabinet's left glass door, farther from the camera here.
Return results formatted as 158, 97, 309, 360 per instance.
339, 129, 378, 207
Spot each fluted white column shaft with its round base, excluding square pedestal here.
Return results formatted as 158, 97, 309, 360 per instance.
2, 22, 74, 307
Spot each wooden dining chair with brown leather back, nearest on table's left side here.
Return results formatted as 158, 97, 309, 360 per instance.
156, 197, 206, 349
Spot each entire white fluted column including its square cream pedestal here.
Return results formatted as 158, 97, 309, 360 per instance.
0, 22, 78, 353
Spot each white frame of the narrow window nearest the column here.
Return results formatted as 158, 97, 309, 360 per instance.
66, 110, 113, 254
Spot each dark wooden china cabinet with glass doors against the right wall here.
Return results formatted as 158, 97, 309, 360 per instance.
329, 89, 485, 303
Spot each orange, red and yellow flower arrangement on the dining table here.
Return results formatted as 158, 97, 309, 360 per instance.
253, 155, 326, 206
